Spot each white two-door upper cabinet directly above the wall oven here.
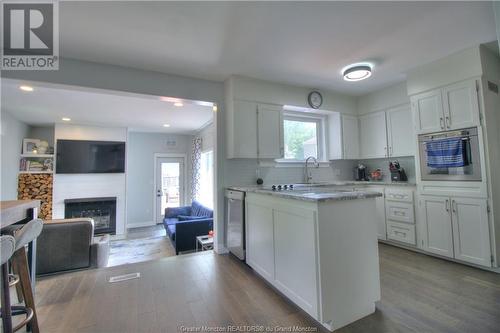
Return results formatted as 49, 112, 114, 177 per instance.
411, 80, 479, 133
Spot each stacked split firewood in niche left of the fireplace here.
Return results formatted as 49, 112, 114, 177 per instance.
17, 173, 53, 220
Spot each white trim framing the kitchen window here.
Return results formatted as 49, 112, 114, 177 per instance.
276, 111, 329, 164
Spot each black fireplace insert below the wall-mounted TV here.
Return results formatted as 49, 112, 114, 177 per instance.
64, 197, 116, 235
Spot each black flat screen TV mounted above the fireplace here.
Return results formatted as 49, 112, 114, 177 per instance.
56, 140, 125, 173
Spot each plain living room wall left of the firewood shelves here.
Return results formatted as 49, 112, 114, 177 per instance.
0, 110, 29, 200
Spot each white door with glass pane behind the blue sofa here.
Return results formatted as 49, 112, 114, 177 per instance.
155, 157, 185, 223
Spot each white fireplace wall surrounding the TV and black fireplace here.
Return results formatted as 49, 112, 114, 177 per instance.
52, 124, 127, 235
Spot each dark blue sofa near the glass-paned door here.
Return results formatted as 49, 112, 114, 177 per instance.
163, 201, 214, 254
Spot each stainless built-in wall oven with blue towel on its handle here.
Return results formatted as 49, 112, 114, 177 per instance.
418, 127, 481, 181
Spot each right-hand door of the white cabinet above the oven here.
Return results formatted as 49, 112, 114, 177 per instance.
443, 80, 479, 130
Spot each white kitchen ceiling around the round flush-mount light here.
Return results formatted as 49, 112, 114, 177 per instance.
60, 1, 496, 95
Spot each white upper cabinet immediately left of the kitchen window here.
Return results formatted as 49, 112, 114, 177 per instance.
226, 100, 284, 158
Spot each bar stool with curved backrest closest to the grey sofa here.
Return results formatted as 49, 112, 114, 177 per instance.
2, 219, 43, 333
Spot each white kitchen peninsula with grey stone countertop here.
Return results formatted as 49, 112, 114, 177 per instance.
240, 186, 382, 331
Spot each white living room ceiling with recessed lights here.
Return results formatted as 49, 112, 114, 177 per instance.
2, 79, 213, 134
